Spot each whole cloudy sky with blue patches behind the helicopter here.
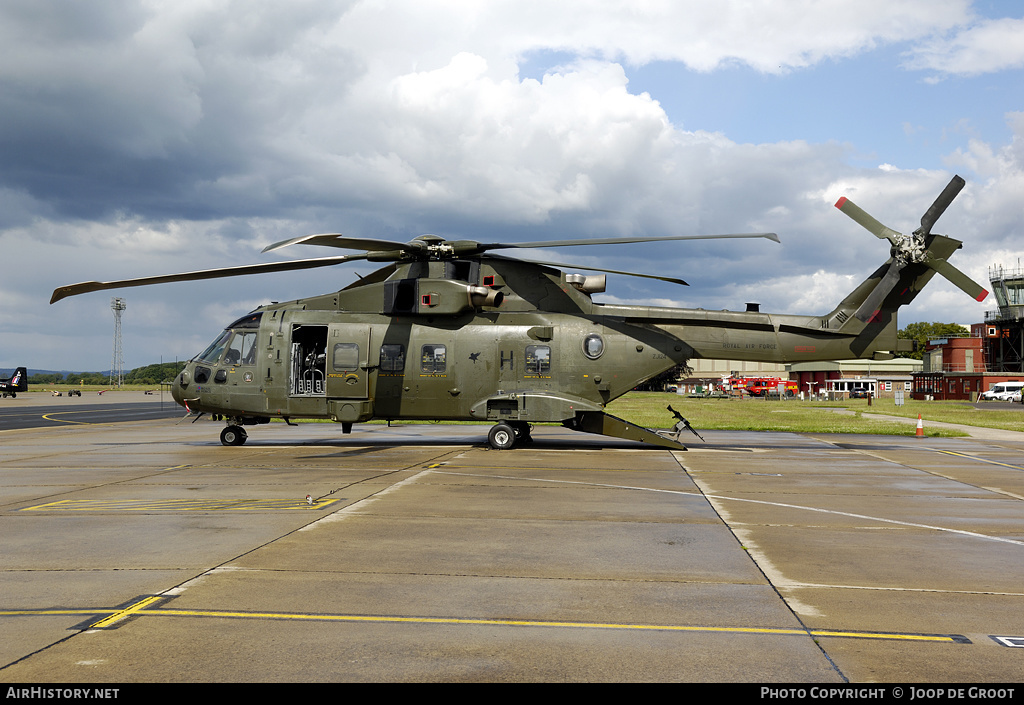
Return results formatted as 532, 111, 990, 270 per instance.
0, 0, 1024, 371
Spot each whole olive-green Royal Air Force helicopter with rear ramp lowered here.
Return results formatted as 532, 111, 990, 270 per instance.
50, 176, 988, 450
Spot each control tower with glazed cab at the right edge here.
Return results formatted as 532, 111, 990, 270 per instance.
983, 262, 1024, 372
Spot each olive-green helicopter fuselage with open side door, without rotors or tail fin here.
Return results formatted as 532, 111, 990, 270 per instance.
172, 259, 897, 423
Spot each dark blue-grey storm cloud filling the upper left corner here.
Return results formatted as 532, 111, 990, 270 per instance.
0, 2, 368, 219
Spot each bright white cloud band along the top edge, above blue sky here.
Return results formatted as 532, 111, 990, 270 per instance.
336, 0, 970, 73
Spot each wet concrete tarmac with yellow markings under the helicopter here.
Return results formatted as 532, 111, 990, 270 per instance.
0, 392, 1024, 683
